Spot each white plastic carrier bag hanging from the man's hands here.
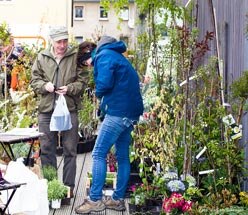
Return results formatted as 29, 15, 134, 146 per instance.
50, 94, 72, 131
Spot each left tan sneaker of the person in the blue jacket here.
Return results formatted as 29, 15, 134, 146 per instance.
75, 199, 105, 214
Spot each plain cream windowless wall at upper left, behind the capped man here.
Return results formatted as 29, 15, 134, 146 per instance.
0, 0, 70, 46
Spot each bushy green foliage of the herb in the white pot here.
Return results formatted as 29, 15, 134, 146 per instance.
47, 179, 68, 201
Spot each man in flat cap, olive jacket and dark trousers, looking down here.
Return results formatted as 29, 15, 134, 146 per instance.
31, 26, 85, 202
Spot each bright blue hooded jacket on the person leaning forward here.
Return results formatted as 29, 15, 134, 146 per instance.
93, 37, 144, 120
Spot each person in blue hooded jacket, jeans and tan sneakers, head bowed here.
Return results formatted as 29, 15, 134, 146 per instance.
75, 36, 144, 214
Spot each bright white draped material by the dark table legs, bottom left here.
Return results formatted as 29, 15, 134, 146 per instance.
0, 160, 49, 215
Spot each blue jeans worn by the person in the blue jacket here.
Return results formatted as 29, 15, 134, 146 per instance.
90, 115, 133, 201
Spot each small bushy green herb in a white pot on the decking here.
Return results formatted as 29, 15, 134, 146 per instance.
48, 178, 68, 208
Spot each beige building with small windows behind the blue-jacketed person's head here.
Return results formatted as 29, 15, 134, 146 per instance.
71, 0, 136, 45
